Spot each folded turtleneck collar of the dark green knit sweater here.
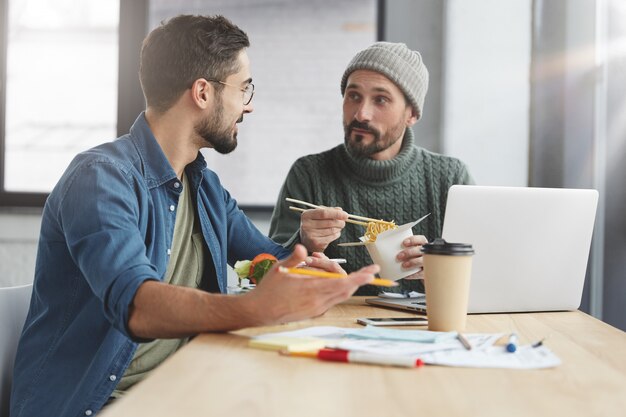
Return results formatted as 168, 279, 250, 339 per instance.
341, 128, 417, 182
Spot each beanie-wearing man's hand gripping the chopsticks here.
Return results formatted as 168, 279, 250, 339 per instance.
300, 207, 348, 252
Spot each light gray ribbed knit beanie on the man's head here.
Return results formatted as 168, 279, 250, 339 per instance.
341, 42, 428, 119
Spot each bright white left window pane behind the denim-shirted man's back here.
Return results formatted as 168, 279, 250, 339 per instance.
0, 0, 119, 205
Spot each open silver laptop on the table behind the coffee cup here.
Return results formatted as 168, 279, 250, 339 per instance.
366, 185, 598, 313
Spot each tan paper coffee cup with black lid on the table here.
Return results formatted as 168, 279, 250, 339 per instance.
422, 239, 474, 332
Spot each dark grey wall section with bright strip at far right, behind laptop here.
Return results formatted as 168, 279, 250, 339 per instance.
529, 0, 626, 329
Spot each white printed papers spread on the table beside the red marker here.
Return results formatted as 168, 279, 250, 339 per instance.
250, 326, 561, 369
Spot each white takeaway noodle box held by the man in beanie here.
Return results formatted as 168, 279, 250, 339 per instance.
365, 222, 420, 281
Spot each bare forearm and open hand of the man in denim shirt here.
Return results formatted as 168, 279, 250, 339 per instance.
128, 245, 372, 339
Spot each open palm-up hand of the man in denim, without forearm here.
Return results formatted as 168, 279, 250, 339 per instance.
245, 245, 379, 325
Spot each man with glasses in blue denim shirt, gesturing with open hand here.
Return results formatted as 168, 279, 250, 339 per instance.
11, 16, 378, 417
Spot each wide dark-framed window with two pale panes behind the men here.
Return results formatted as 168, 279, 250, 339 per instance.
0, 0, 383, 209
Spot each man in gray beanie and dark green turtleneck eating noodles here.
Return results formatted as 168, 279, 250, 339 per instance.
270, 42, 473, 295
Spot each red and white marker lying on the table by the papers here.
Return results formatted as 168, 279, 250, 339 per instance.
279, 349, 424, 368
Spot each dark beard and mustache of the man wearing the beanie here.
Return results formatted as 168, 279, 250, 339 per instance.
343, 120, 406, 158
